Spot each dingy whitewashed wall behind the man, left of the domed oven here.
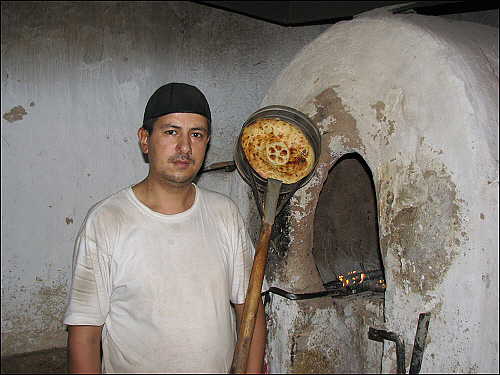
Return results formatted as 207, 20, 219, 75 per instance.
1, 1, 327, 355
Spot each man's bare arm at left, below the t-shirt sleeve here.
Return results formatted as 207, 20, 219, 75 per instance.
68, 326, 102, 374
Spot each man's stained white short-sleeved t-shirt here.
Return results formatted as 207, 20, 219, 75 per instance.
64, 187, 262, 373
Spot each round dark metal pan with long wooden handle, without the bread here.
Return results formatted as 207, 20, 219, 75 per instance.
231, 105, 321, 374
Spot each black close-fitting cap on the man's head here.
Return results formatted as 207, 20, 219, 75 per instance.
144, 82, 212, 121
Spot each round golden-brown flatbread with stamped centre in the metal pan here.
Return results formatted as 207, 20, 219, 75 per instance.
241, 118, 314, 184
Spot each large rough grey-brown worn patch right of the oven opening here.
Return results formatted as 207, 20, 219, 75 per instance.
382, 168, 463, 299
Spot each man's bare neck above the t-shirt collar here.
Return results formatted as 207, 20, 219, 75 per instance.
132, 176, 196, 215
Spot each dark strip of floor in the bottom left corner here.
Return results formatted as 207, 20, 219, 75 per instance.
2, 348, 66, 374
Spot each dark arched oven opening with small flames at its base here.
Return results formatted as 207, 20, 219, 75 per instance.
312, 153, 385, 298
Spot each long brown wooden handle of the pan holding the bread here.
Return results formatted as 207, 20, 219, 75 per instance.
231, 222, 273, 374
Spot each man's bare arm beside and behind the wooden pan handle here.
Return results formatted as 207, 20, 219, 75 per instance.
234, 298, 267, 374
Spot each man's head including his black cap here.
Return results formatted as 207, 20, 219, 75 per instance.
138, 83, 211, 187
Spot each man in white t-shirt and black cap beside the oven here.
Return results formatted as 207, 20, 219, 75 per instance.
64, 83, 266, 373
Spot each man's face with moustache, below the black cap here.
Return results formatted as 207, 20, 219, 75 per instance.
138, 113, 210, 186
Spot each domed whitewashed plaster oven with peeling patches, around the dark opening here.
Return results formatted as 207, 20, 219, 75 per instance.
261, 10, 498, 373
